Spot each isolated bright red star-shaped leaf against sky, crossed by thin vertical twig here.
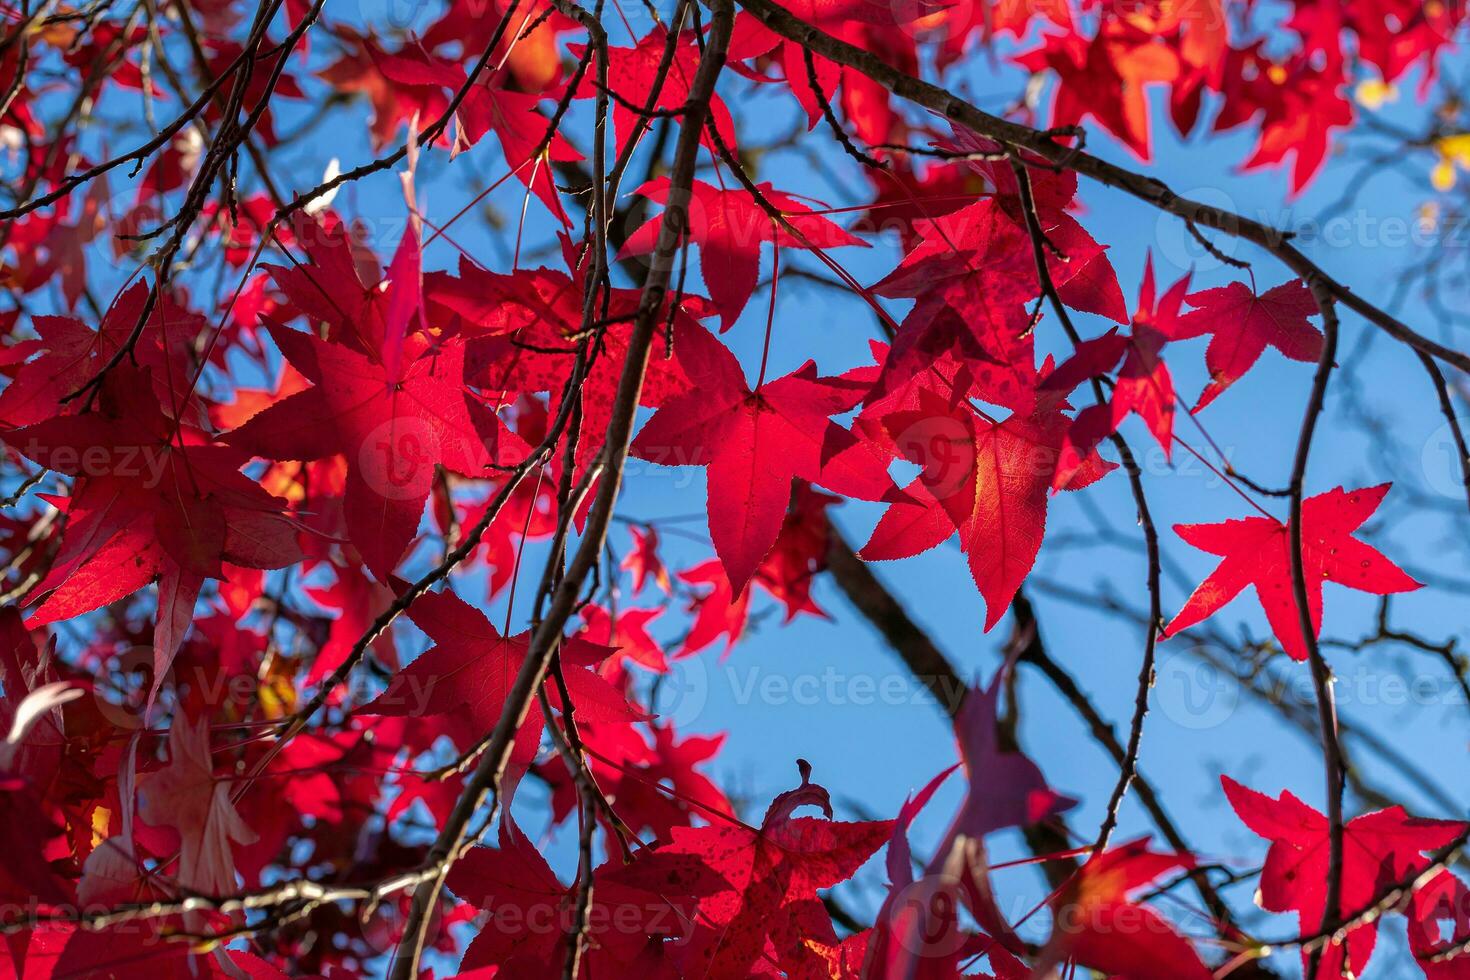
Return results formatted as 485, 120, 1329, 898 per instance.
1164, 483, 1420, 660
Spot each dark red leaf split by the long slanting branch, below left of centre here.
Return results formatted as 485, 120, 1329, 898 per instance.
362, 592, 639, 764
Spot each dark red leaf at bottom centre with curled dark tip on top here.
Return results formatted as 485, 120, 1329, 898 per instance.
626, 761, 894, 977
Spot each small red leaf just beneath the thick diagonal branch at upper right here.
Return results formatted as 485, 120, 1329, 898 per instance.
1172, 279, 1322, 411
